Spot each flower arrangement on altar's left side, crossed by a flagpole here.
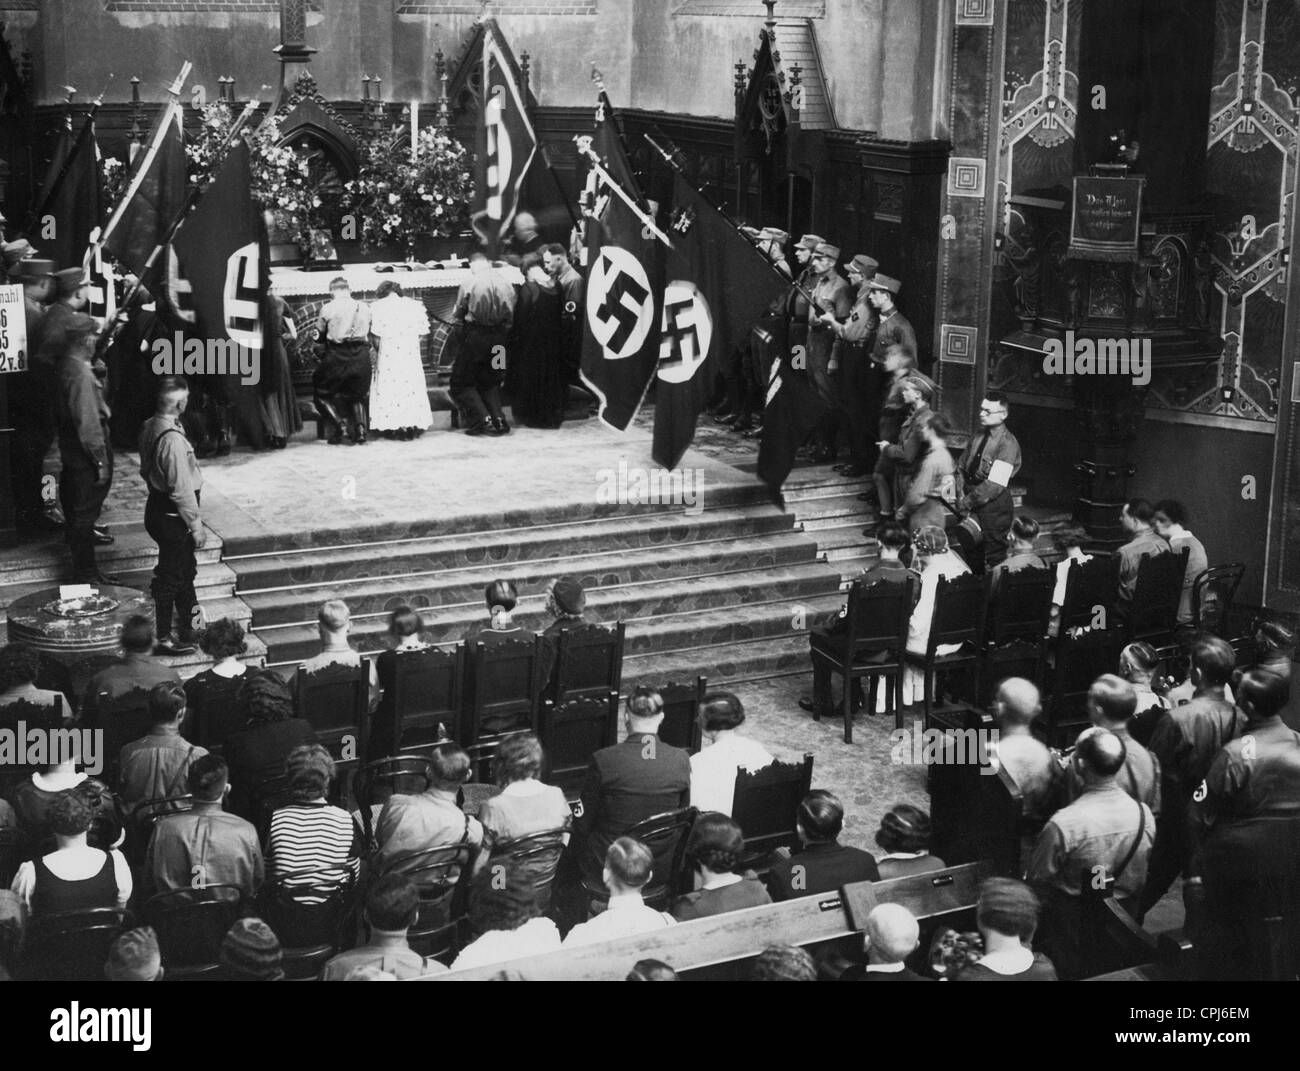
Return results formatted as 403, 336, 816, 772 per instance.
185, 100, 322, 251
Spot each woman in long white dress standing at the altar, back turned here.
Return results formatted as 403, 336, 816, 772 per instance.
371, 279, 433, 439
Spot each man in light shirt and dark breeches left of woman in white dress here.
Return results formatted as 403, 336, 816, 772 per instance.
312, 276, 371, 446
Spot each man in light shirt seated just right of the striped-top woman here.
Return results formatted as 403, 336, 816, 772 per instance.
372, 743, 484, 885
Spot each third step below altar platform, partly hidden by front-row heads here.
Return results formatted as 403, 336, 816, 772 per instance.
259, 561, 840, 664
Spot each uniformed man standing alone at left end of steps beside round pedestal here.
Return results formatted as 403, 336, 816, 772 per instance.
140, 376, 207, 654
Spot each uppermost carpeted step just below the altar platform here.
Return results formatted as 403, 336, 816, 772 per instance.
226, 506, 794, 593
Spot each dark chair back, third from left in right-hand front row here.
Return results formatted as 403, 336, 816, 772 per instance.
982, 563, 1055, 707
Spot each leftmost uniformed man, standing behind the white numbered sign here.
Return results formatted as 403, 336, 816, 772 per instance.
9, 257, 64, 532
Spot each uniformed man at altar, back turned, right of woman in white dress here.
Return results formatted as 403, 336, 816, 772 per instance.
451, 252, 514, 435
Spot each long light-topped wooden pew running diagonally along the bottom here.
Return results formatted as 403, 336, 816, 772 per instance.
419, 862, 993, 981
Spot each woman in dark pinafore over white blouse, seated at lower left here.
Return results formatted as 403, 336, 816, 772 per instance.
12, 792, 131, 916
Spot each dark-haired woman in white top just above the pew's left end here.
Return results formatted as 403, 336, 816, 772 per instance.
451, 863, 560, 971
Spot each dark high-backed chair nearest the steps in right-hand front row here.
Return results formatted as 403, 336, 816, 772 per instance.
809, 573, 918, 743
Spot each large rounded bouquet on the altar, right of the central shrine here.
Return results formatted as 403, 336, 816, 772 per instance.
343, 127, 475, 252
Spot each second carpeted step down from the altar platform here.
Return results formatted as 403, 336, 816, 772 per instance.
241, 532, 816, 629
